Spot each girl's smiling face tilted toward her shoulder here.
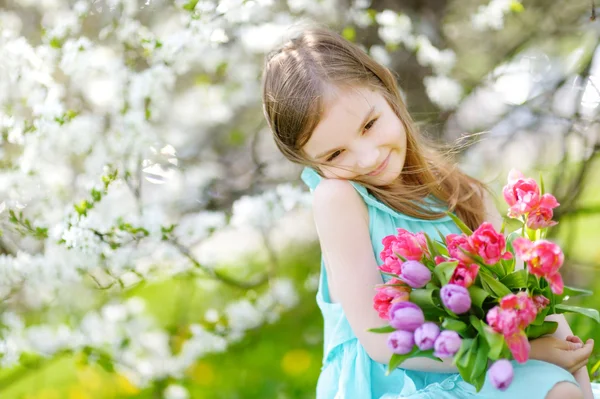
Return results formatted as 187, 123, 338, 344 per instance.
303, 88, 406, 186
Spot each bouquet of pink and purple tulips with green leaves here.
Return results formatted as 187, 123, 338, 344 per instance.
370, 170, 600, 391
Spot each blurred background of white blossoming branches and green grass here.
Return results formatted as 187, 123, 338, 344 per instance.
0, 0, 600, 399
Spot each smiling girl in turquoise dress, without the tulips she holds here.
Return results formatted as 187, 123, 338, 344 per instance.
263, 29, 593, 399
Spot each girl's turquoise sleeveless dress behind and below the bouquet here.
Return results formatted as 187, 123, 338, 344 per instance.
302, 168, 576, 399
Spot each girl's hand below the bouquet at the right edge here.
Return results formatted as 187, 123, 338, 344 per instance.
529, 336, 594, 373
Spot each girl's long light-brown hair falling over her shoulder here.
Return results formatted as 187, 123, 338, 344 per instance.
263, 28, 486, 229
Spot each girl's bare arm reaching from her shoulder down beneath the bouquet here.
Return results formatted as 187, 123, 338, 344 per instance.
313, 179, 458, 373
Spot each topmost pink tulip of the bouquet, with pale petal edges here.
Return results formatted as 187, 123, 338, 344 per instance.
502, 169, 540, 218
